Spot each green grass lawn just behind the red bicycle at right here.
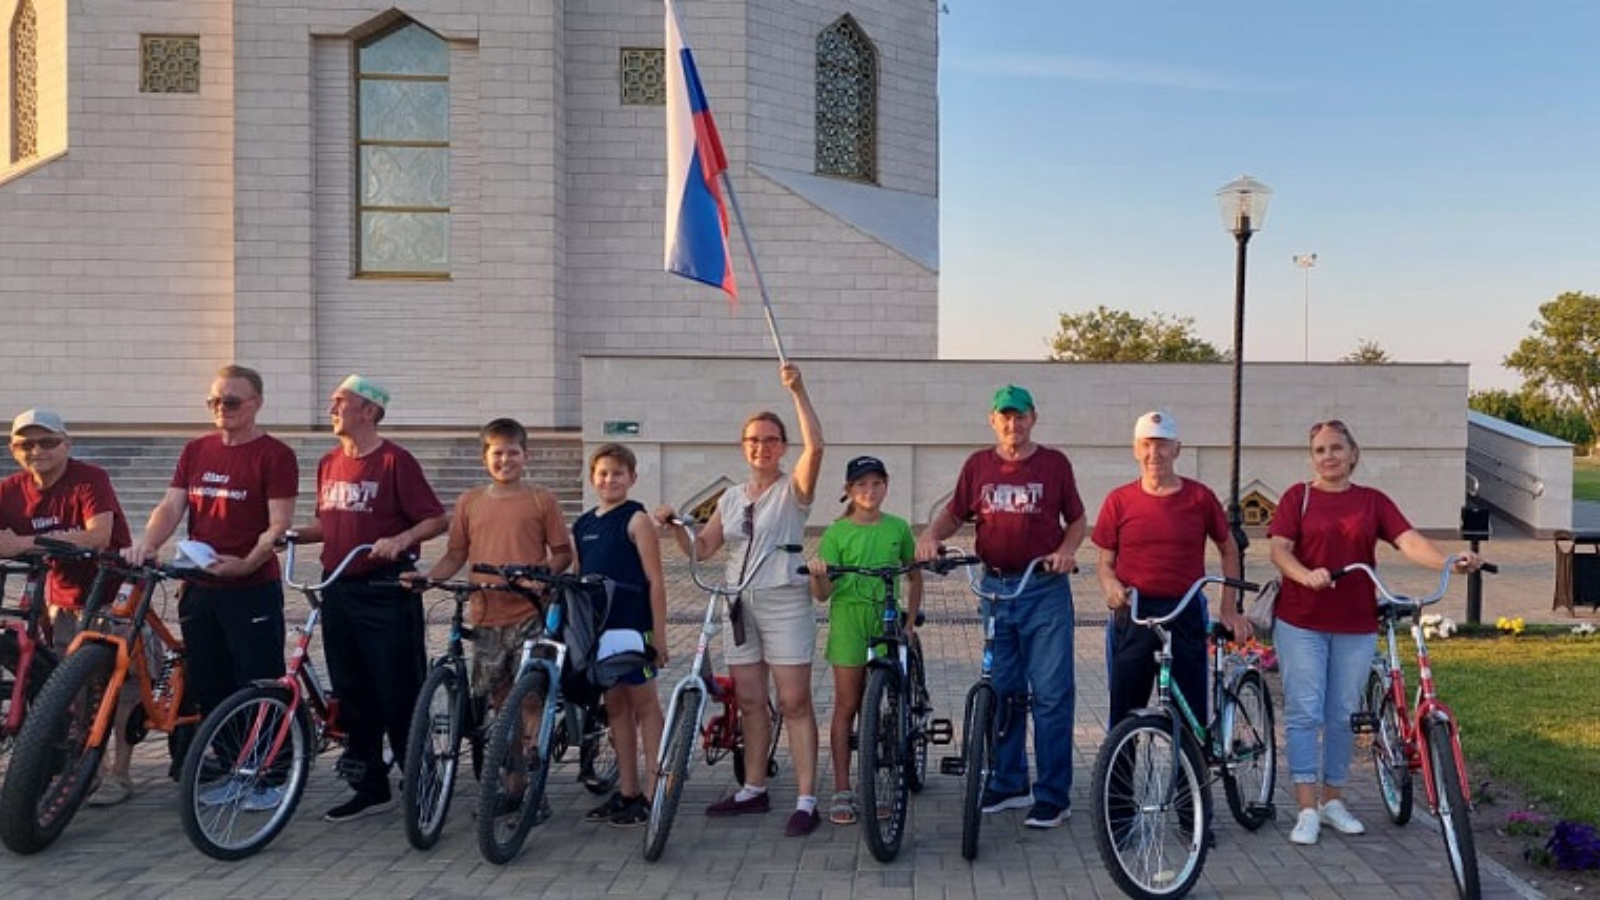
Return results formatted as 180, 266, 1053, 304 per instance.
1427, 636, 1600, 825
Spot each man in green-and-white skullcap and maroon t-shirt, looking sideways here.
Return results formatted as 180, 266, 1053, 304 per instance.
299, 375, 450, 822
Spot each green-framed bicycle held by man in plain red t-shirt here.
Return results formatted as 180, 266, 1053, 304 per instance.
1091, 575, 1278, 897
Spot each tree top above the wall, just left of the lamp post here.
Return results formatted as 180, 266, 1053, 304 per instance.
1048, 306, 1229, 362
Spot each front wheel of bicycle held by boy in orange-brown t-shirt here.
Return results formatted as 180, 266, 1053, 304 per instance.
400, 663, 469, 850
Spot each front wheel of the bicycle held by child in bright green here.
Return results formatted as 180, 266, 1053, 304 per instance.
861, 666, 910, 863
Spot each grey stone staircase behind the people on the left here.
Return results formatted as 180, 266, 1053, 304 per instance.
72, 432, 584, 522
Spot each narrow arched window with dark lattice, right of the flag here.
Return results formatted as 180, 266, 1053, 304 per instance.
816, 16, 878, 181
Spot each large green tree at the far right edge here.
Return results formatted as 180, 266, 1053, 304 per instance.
1506, 291, 1600, 451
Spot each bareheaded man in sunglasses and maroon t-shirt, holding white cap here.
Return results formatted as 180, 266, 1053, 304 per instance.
123, 365, 299, 730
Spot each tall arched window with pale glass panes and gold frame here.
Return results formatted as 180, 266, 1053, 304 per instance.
355, 19, 450, 277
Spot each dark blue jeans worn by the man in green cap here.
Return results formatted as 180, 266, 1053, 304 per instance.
982, 575, 1075, 809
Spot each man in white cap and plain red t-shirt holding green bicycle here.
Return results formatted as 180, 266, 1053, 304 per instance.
1091, 412, 1250, 729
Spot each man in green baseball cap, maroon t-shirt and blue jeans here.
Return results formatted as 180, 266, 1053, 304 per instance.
917, 384, 1085, 828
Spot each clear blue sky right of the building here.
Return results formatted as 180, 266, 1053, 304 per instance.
939, 0, 1600, 389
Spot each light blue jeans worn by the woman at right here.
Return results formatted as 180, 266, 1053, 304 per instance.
1272, 618, 1376, 788
